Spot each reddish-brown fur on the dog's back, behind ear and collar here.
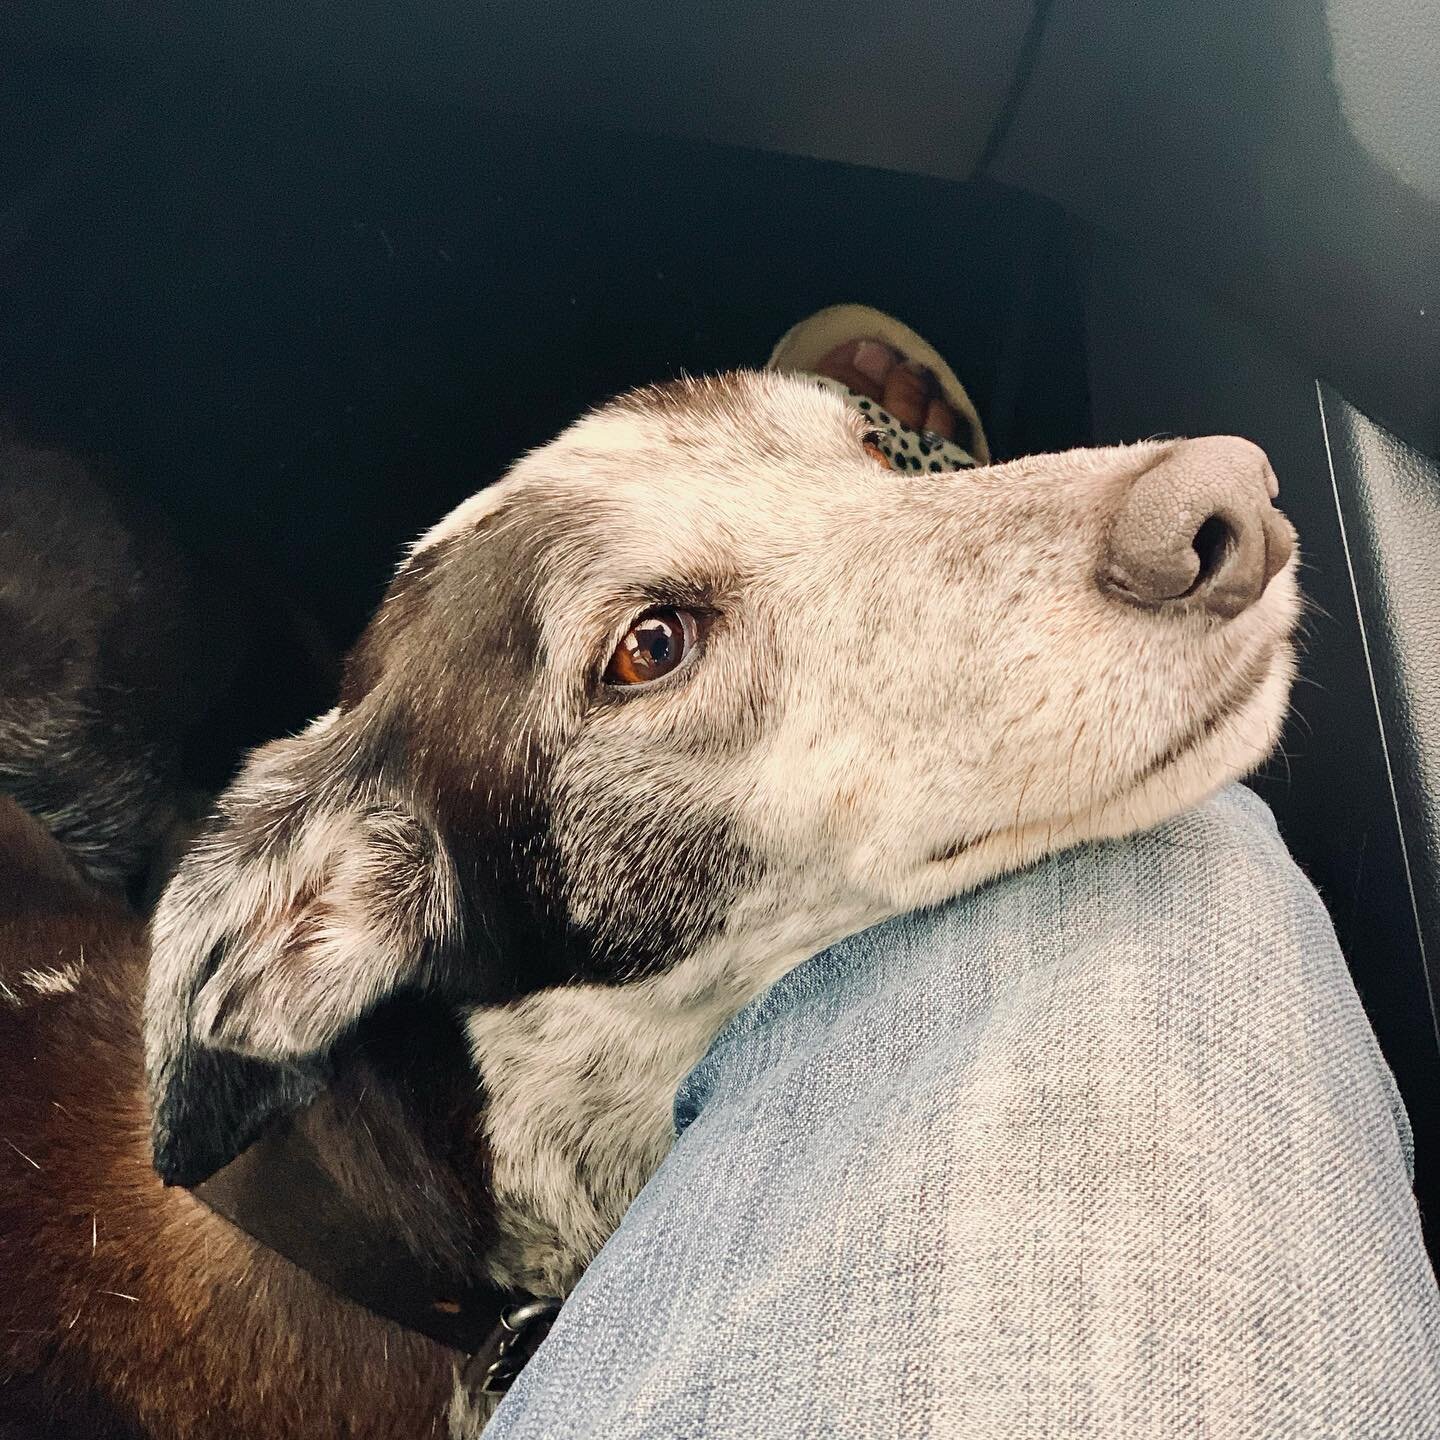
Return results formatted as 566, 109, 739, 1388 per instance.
0, 801, 451, 1440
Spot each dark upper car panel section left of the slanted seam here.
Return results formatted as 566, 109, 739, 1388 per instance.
0, 0, 1031, 185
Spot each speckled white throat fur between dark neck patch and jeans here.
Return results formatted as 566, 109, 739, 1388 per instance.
467, 896, 873, 1296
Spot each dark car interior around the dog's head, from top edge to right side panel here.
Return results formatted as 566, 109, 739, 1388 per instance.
0, 0, 1440, 1253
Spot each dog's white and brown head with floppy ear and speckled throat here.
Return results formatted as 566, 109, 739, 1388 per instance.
2, 373, 1299, 1434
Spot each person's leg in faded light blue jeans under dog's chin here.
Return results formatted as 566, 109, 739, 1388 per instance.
487, 788, 1440, 1440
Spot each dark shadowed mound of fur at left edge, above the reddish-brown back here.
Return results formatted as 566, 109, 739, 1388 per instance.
0, 425, 198, 884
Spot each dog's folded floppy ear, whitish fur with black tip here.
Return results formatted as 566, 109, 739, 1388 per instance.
145, 716, 461, 1185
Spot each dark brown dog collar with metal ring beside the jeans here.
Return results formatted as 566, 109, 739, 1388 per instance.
200, 1120, 560, 1395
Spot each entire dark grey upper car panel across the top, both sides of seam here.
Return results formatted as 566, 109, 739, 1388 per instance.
11, 0, 1440, 454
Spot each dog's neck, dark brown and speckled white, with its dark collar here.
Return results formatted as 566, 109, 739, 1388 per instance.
200, 897, 868, 1348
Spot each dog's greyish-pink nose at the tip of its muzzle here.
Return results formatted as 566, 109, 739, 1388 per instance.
1096, 435, 1295, 619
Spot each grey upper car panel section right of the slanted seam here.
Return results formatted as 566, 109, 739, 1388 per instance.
994, 0, 1440, 454
